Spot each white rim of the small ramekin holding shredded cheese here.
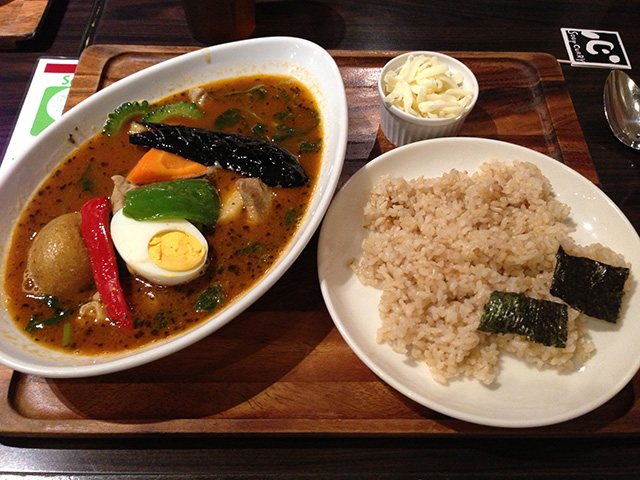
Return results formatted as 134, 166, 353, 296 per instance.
377, 50, 480, 126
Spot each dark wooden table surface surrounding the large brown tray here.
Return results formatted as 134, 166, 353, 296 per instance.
0, 0, 640, 478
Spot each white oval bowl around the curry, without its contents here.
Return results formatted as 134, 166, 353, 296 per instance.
0, 37, 348, 378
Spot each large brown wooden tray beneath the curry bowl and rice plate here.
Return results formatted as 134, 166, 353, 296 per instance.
5, 46, 640, 436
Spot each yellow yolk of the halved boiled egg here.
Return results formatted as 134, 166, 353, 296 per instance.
148, 230, 205, 272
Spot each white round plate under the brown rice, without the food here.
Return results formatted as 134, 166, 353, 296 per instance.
318, 138, 640, 427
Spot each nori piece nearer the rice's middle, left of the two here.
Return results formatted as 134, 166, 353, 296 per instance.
478, 292, 567, 348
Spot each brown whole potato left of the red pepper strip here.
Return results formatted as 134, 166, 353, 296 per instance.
25, 213, 93, 298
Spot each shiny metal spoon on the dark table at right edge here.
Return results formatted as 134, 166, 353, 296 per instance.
603, 70, 640, 150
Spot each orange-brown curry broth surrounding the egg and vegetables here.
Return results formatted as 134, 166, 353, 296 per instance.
3, 75, 322, 355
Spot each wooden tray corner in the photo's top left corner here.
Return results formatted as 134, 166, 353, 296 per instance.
0, 0, 49, 48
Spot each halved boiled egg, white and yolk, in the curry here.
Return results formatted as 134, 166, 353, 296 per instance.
111, 209, 209, 285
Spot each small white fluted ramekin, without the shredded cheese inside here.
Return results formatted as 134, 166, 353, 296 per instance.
378, 51, 480, 147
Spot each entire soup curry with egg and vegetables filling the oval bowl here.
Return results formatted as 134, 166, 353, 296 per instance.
3, 75, 323, 355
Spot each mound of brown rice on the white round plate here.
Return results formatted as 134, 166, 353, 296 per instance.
352, 161, 624, 385
